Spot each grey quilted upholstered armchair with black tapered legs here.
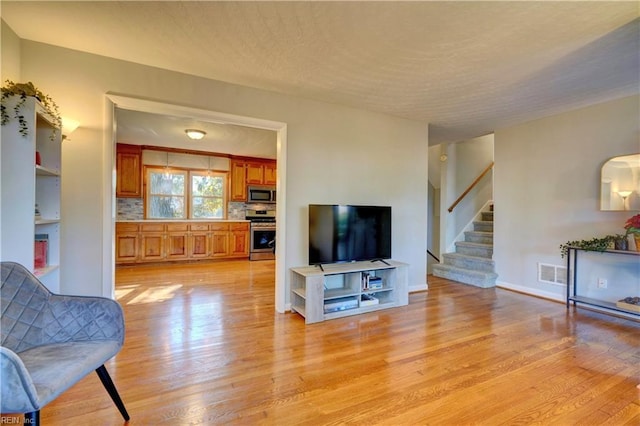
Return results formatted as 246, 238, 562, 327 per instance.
0, 262, 129, 425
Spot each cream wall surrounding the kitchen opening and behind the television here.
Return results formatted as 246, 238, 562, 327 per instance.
16, 41, 428, 299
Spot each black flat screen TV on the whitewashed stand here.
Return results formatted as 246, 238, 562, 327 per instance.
309, 204, 391, 265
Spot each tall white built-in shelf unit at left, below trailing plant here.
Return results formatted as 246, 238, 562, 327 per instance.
0, 96, 62, 293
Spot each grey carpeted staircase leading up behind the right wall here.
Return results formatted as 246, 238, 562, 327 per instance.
433, 205, 498, 288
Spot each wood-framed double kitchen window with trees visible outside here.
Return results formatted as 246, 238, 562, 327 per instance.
145, 167, 227, 219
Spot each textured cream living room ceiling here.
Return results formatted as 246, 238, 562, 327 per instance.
2, 0, 640, 144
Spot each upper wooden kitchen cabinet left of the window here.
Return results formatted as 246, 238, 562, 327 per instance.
116, 143, 142, 198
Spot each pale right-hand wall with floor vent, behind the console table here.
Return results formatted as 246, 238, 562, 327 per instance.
494, 96, 640, 299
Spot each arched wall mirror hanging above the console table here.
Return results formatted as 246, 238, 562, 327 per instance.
600, 154, 640, 210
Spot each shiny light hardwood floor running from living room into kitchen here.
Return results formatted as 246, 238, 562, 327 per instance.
6, 261, 640, 425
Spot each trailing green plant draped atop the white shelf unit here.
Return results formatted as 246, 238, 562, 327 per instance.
0, 80, 62, 139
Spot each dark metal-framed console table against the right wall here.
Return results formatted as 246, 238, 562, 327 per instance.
567, 247, 640, 318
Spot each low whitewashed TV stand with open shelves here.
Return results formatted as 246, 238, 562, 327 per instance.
291, 259, 409, 324
